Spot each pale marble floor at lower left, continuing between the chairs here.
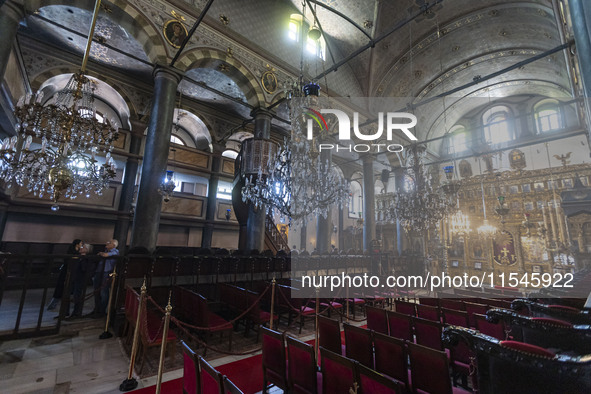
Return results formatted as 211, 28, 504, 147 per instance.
0, 319, 324, 394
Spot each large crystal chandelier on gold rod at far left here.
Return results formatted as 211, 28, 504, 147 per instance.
0, 0, 119, 210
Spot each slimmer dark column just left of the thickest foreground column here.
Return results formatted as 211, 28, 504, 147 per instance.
113, 121, 146, 252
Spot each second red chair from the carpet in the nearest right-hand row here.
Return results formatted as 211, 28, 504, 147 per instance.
286, 336, 322, 394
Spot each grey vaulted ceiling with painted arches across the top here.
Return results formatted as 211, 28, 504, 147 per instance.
17, 0, 572, 145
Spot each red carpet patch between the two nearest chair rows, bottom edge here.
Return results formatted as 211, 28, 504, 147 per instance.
216, 354, 263, 394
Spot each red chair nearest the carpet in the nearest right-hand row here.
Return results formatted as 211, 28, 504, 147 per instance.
260, 326, 288, 393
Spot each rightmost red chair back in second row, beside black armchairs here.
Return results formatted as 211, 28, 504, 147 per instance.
408, 343, 452, 394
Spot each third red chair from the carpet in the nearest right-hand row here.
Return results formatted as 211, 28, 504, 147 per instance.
320, 347, 358, 394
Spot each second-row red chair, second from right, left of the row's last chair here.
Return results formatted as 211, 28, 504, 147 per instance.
373, 332, 410, 389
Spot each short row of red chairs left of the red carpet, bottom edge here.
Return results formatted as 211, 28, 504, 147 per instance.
181, 341, 242, 394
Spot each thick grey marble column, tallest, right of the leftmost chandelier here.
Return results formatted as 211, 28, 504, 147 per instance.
131, 65, 183, 252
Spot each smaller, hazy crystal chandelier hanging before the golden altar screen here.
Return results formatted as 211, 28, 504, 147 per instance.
394, 145, 455, 233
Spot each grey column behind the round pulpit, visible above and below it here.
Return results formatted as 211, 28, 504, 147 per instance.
246, 108, 272, 251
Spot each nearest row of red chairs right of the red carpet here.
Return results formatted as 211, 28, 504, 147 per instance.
262, 328, 405, 394
